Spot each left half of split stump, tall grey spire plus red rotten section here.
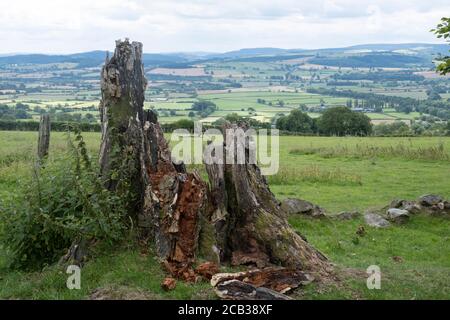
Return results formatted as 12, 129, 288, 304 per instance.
100, 40, 206, 278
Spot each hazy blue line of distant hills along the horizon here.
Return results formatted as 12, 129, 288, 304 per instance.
0, 43, 449, 68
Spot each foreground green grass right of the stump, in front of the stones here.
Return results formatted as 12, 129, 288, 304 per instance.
289, 216, 450, 300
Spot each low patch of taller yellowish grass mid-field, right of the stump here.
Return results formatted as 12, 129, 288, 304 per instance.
268, 165, 362, 185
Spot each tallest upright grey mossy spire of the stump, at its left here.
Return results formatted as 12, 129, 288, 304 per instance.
100, 40, 147, 200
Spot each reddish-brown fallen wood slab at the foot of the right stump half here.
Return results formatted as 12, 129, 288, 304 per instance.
211, 268, 314, 293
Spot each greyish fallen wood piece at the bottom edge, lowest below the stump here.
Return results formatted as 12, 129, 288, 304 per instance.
214, 280, 292, 300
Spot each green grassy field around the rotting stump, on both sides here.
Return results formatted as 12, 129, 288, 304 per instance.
0, 132, 450, 299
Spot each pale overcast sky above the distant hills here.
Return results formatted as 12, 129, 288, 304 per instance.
0, 0, 450, 53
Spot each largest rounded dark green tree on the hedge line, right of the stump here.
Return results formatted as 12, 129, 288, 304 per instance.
318, 107, 372, 136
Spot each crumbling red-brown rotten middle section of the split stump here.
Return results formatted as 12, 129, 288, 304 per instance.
142, 115, 207, 280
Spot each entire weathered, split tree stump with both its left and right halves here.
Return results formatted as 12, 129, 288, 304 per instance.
100, 39, 330, 290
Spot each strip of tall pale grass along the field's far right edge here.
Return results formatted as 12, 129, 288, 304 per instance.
289, 143, 450, 161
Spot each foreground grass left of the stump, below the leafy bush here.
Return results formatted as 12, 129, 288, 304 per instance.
0, 248, 213, 299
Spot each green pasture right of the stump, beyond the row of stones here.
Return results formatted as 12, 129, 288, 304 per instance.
269, 137, 450, 212
